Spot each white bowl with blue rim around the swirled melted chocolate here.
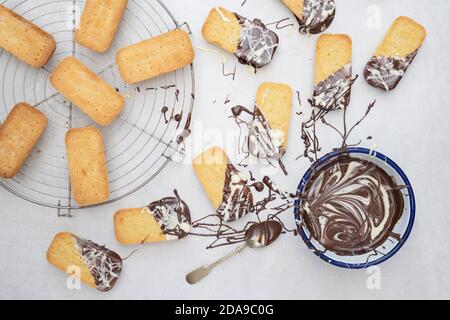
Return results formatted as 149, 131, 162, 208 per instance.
294, 147, 416, 269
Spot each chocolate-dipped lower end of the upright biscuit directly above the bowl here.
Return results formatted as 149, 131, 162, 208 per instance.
312, 63, 355, 111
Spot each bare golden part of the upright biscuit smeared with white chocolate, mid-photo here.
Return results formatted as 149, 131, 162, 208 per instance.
256, 82, 292, 147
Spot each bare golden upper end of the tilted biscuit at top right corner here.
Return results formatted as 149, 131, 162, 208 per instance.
374, 17, 426, 57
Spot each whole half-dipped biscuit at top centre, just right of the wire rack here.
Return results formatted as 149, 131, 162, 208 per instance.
202, 7, 279, 68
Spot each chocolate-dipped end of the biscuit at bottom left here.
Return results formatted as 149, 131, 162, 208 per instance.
73, 236, 122, 291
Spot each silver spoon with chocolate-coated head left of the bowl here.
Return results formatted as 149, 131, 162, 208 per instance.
186, 220, 283, 284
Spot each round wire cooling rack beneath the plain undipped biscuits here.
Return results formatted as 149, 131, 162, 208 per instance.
0, 0, 195, 216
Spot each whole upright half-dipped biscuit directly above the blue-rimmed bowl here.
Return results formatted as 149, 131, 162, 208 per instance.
313, 34, 353, 110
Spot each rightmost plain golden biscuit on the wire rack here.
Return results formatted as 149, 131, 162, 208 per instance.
116, 29, 195, 83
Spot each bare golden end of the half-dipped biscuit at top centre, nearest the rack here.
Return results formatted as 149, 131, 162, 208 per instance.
202, 7, 242, 53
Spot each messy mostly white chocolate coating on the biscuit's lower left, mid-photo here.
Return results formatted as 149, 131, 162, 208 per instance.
231, 105, 287, 175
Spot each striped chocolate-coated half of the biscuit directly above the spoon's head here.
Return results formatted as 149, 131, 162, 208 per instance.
217, 164, 254, 222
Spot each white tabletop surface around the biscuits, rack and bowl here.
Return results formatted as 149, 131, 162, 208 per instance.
0, 0, 450, 299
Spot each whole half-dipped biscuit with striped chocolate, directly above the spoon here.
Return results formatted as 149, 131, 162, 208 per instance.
193, 147, 254, 221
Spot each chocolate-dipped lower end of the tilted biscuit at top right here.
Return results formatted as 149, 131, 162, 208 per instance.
364, 50, 418, 91
